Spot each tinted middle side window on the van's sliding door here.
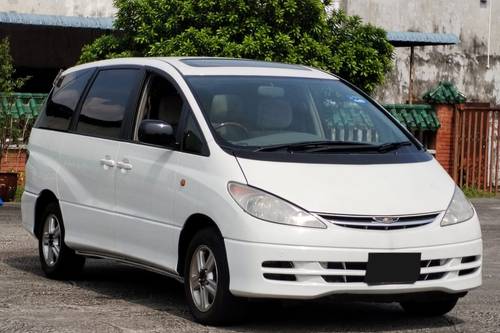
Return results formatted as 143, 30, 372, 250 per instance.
76, 69, 140, 138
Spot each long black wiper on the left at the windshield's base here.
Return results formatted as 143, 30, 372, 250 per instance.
254, 141, 378, 152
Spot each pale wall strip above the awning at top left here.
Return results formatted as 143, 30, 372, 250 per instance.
0, 0, 116, 17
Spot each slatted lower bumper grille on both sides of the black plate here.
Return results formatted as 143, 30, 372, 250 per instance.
262, 256, 481, 283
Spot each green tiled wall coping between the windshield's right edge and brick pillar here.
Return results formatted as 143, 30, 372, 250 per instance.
384, 104, 441, 131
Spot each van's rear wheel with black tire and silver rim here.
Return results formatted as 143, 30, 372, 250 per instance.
38, 202, 85, 280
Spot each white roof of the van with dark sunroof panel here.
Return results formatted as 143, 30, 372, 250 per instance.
68, 57, 337, 80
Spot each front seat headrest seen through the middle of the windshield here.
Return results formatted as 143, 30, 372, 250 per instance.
257, 99, 293, 130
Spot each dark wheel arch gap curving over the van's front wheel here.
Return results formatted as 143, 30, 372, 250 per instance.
177, 213, 224, 276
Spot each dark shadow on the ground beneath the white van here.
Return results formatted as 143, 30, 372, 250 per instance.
4, 256, 463, 332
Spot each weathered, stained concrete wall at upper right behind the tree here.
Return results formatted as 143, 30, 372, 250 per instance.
340, 0, 500, 104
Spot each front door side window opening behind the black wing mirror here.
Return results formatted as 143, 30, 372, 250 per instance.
134, 74, 184, 140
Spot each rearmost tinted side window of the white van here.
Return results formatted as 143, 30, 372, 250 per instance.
36, 69, 93, 131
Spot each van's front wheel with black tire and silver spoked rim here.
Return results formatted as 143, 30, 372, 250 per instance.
184, 228, 245, 325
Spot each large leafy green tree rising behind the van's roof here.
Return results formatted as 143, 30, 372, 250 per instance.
80, 0, 392, 92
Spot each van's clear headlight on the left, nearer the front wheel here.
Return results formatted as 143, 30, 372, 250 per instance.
227, 182, 326, 229
